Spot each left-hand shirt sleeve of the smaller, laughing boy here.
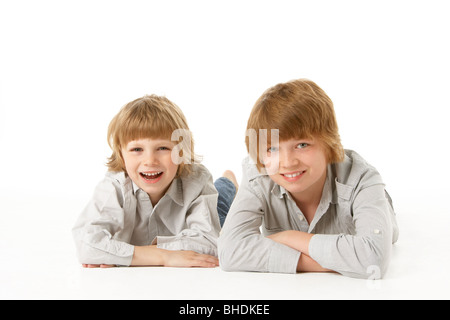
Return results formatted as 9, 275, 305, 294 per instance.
72, 178, 134, 266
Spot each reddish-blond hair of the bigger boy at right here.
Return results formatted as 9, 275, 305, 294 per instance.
246, 79, 344, 170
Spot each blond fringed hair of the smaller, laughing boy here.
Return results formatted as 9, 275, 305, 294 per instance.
107, 95, 198, 177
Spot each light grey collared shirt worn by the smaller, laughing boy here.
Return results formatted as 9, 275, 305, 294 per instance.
73, 165, 220, 266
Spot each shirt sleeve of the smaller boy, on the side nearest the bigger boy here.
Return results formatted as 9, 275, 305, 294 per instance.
157, 182, 220, 257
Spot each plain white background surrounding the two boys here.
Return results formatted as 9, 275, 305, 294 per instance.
0, 0, 450, 299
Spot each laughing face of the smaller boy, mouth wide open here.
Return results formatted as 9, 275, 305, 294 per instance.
122, 139, 178, 205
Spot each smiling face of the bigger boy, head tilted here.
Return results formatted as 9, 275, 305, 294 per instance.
263, 139, 328, 202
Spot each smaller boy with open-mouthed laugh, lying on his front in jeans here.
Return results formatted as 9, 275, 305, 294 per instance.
73, 95, 236, 268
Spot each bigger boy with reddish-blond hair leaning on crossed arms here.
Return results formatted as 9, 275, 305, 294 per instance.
219, 80, 398, 279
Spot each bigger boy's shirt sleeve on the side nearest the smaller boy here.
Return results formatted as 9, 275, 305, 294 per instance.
219, 173, 300, 273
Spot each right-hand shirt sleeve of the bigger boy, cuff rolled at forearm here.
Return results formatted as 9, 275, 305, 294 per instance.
309, 184, 396, 279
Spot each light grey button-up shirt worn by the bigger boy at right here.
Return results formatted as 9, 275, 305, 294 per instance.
219, 150, 398, 279
